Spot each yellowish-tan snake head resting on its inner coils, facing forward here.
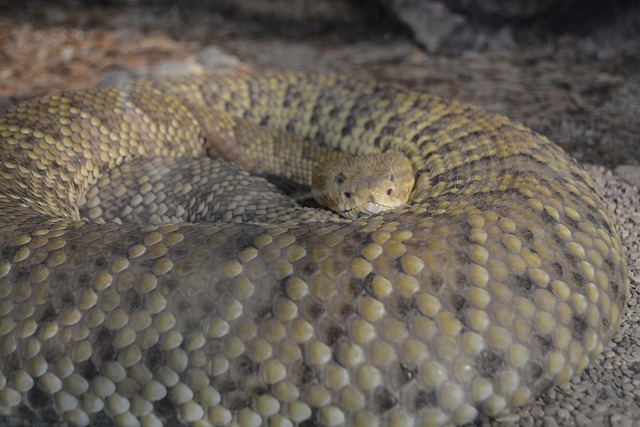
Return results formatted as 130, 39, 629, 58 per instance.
311, 151, 415, 219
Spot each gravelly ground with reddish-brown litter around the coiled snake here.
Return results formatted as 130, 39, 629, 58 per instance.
0, 1, 640, 426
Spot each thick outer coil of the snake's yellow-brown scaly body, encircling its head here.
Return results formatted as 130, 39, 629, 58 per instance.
0, 74, 629, 426
